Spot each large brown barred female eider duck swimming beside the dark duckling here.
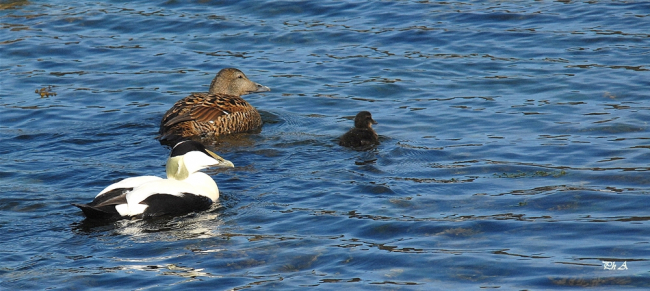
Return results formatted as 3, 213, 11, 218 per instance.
159, 68, 271, 142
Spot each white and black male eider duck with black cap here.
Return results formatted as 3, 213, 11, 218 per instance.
73, 141, 234, 219
